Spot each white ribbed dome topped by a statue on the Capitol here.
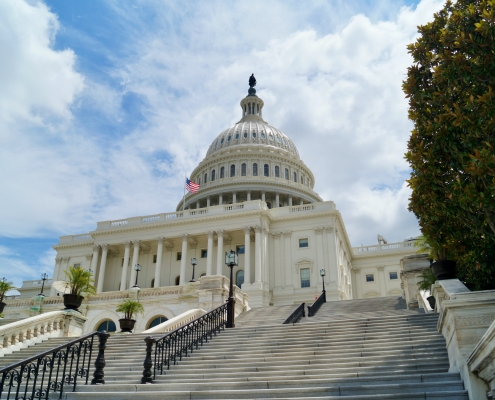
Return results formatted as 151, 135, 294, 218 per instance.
177, 75, 322, 210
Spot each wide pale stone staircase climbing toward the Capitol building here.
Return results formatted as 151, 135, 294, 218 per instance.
51, 299, 468, 400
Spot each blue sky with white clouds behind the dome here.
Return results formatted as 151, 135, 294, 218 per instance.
0, 0, 442, 285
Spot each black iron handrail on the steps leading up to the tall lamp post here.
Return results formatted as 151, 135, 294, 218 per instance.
141, 304, 227, 383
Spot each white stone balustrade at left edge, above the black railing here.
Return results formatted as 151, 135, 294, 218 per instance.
0, 310, 86, 355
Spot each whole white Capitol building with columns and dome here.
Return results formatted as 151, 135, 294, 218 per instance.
13, 76, 416, 331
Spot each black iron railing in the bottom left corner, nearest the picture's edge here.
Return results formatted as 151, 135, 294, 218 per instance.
0, 332, 110, 400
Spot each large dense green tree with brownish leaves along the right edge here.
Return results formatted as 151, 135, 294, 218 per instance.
403, 0, 495, 290
